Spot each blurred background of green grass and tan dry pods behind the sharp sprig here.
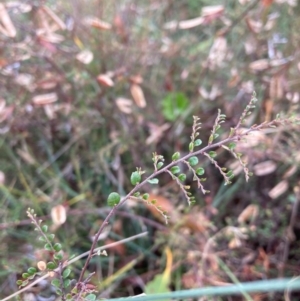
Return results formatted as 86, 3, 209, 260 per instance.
0, 0, 300, 300
